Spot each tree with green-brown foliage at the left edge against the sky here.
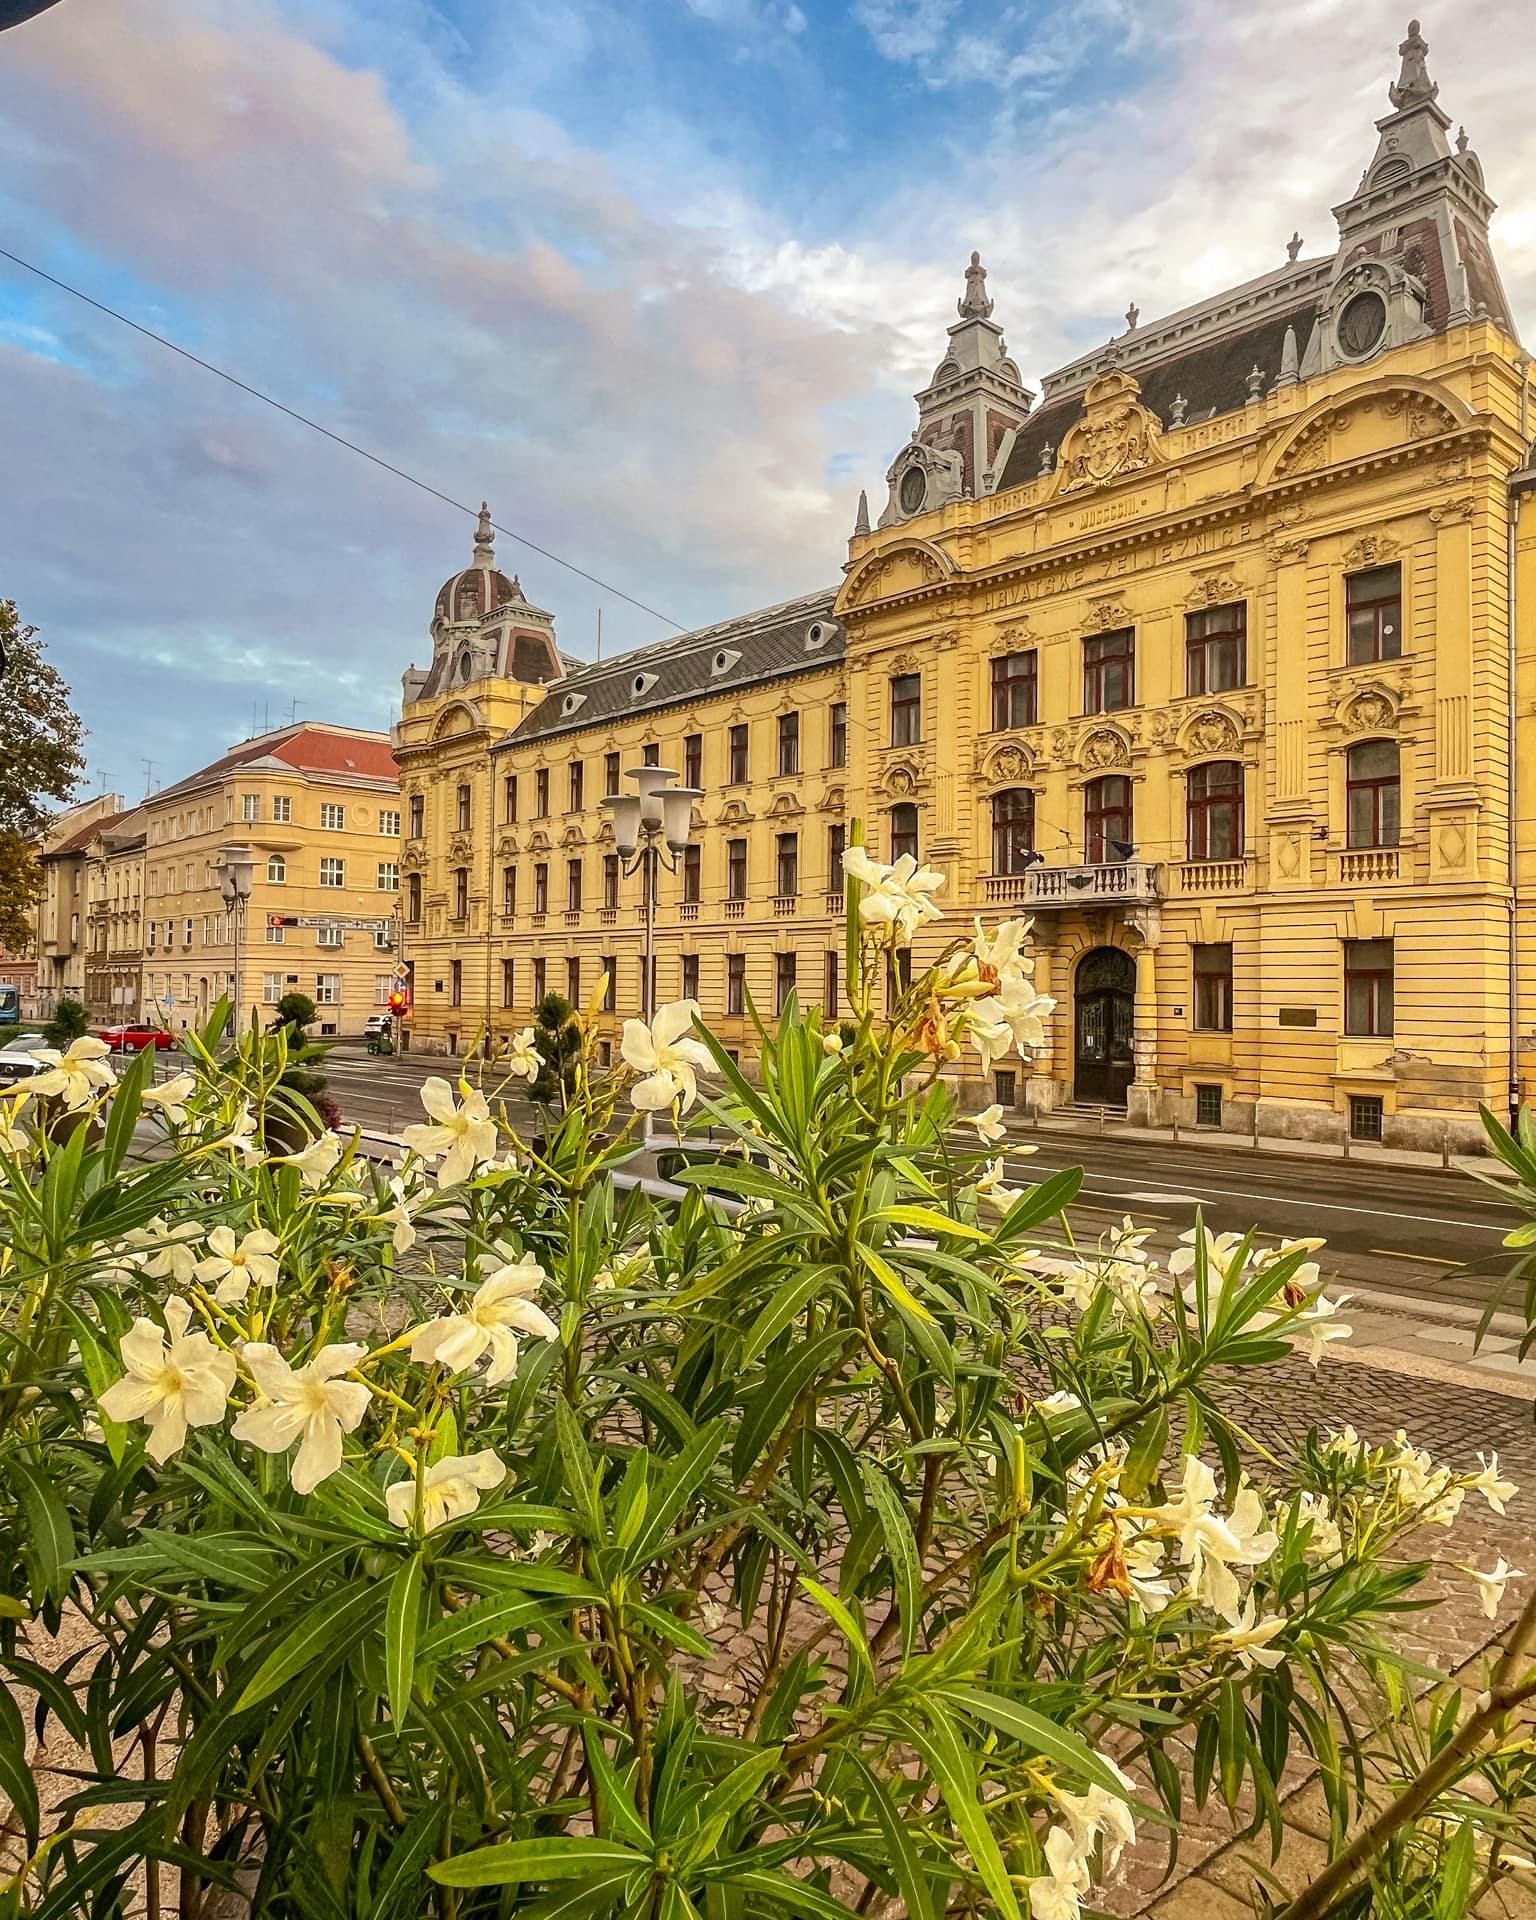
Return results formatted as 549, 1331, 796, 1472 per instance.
0, 601, 84, 954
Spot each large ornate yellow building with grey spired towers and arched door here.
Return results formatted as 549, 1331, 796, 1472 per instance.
397, 29, 1536, 1146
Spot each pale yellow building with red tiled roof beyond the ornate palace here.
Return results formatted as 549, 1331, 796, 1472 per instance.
138, 720, 401, 1035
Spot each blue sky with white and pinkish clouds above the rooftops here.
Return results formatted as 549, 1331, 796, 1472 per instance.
0, 0, 1536, 801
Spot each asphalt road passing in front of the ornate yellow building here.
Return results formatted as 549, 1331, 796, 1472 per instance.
326, 1046, 1523, 1306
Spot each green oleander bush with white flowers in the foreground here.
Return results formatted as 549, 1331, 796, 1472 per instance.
0, 849, 1536, 1920
